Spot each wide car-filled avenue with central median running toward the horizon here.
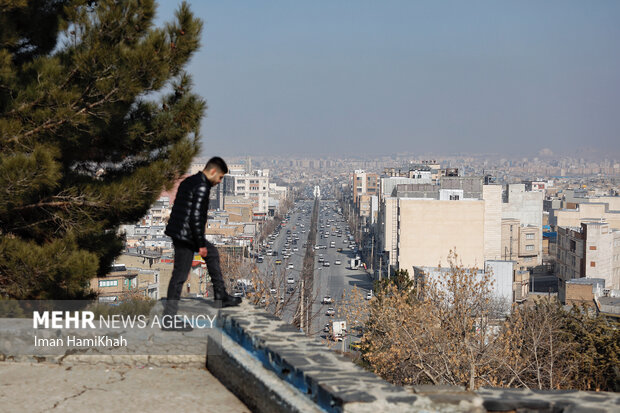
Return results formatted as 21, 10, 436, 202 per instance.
252, 200, 372, 344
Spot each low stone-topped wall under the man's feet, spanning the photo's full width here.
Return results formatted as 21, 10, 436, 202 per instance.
0, 299, 620, 413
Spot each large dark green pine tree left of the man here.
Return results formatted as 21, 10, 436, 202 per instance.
0, 0, 206, 299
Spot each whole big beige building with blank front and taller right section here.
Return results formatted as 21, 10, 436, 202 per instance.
383, 185, 501, 271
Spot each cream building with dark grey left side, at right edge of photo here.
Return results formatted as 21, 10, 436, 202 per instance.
556, 221, 620, 302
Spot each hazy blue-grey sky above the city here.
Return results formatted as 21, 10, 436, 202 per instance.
158, 0, 620, 155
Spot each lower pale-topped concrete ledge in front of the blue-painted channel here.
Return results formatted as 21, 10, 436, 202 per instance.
207, 330, 322, 413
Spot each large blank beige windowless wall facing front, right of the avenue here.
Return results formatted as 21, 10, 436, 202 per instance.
398, 198, 485, 273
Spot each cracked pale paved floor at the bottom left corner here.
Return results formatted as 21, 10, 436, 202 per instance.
0, 362, 250, 413
